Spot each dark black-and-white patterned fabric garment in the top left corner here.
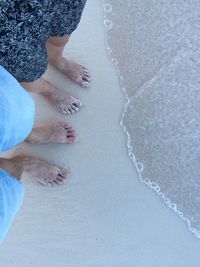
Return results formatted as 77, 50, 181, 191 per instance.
0, 0, 86, 82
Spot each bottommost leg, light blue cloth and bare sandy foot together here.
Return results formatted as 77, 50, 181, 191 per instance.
0, 156, 69, 244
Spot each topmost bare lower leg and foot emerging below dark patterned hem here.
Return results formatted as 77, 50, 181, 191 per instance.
46, 36, 90, 87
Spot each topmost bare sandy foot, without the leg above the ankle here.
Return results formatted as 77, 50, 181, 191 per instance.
52, 57, 91, 88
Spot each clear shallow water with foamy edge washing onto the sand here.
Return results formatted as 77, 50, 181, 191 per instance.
103, 0, 200, 238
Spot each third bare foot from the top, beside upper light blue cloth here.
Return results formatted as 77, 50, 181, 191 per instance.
26, 122, 76, 144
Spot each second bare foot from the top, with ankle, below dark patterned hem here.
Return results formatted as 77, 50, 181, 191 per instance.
21, 78, 82, 115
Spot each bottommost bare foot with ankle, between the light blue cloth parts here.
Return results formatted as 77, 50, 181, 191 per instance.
1, 156, 69, 186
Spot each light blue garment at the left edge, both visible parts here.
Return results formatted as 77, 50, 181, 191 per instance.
0, 66, 35, 243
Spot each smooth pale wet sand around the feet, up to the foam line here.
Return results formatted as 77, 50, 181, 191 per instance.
0, 0, 200, 267
